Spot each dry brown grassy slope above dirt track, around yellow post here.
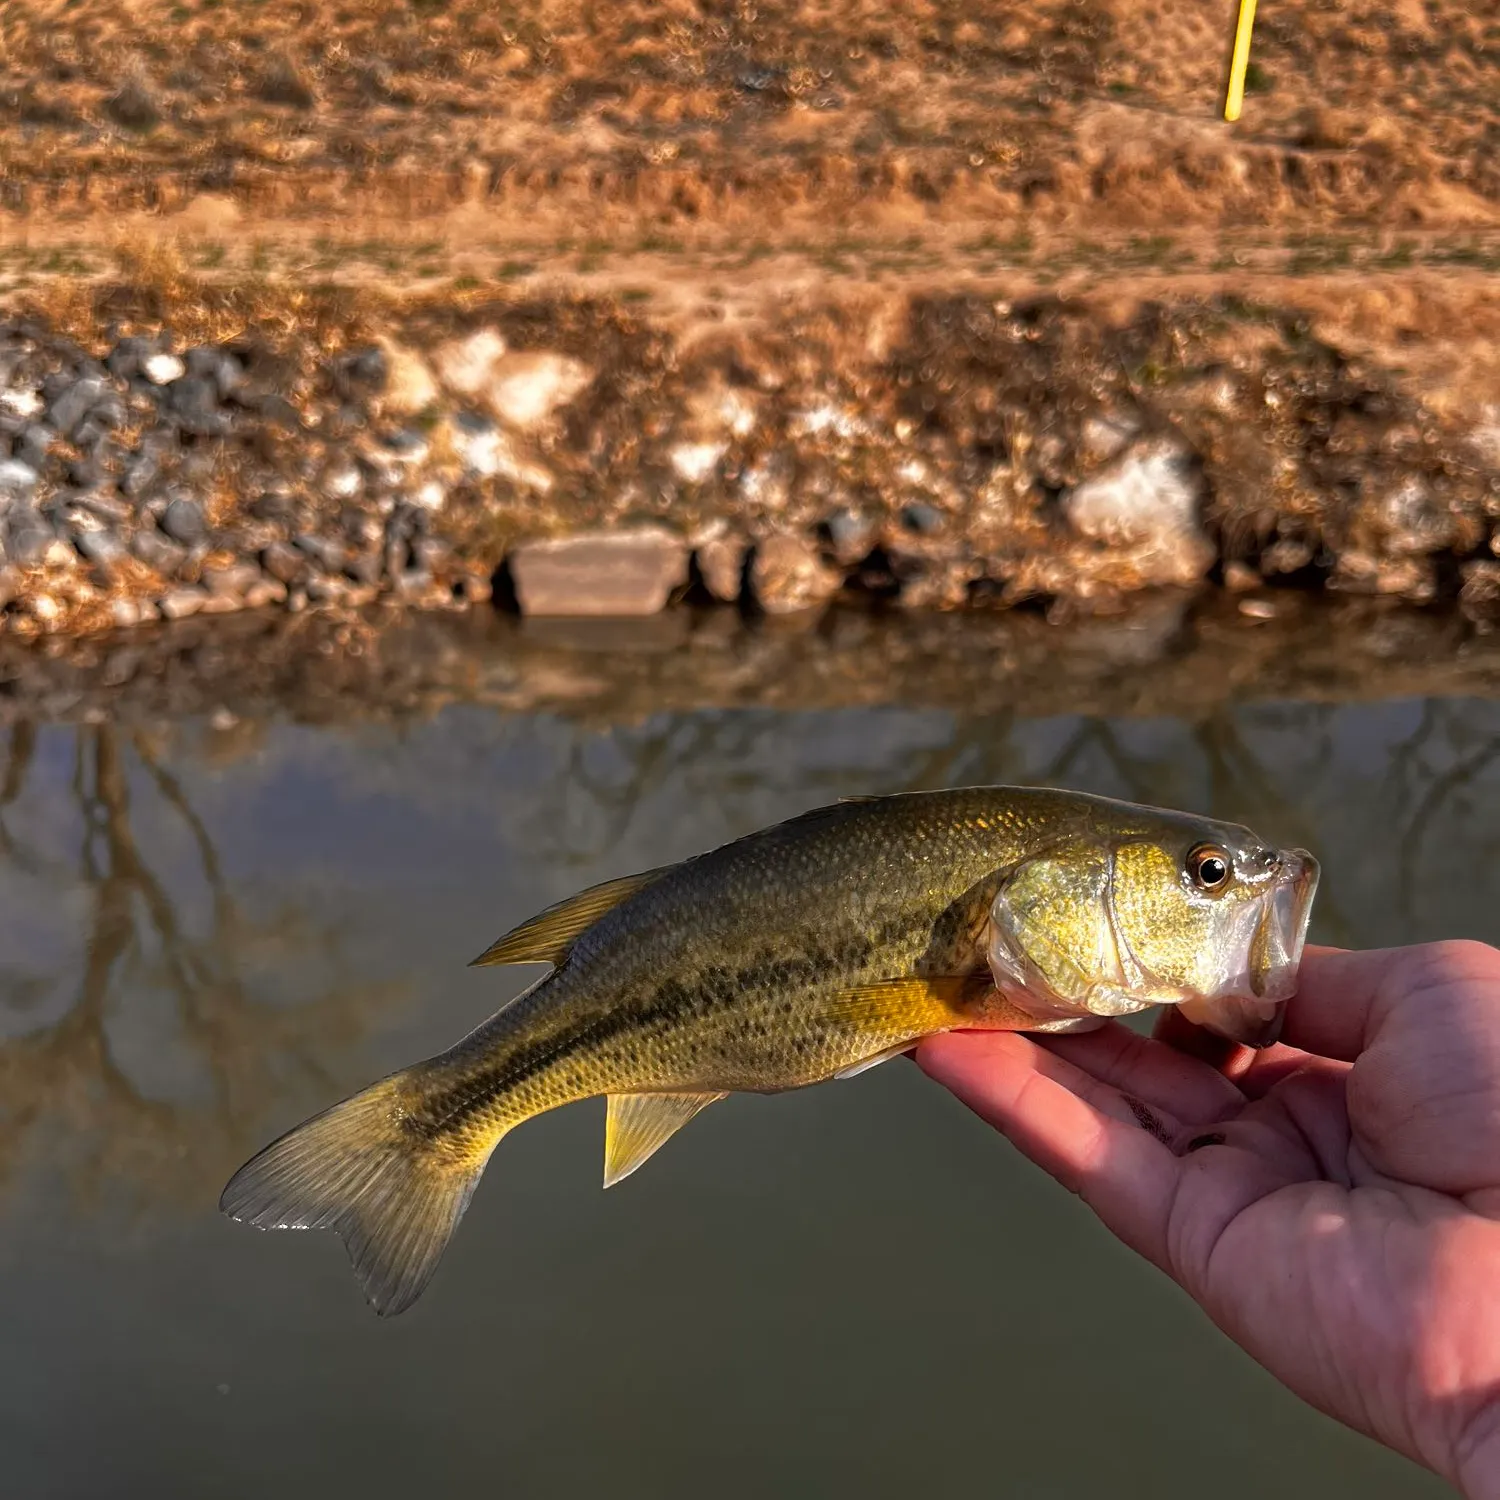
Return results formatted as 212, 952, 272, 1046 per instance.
0, 0, 1500, 243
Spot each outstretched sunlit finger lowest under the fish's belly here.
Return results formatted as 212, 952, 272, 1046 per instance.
917, 1032, 1191, 1271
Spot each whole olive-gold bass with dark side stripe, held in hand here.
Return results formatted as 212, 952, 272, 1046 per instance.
221, 786, 1319, 1317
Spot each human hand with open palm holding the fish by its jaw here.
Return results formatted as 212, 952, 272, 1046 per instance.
917, 942, 1500, 1500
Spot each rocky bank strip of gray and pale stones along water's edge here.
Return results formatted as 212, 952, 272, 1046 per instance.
0, 290, 1500, 638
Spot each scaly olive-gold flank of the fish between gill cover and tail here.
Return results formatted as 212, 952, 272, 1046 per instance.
411, 795, 1016, 1124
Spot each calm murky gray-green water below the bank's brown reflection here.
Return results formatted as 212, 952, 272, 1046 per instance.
0, 639, 1500, 1500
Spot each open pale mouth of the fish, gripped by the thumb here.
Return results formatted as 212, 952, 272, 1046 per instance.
1179, 849, 1320, 1049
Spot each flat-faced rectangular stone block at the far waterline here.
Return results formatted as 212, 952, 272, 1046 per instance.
510, 527, 687, 615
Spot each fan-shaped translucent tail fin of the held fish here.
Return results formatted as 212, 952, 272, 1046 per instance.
219, 1070, 498, 1317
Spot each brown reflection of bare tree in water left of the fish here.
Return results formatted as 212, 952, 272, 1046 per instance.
0, 723, 408, 1224
